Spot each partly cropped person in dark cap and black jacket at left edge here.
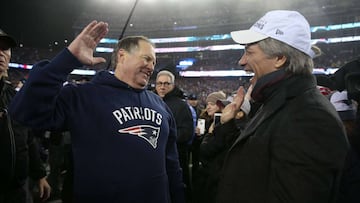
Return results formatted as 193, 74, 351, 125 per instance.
0, 27, 50, 203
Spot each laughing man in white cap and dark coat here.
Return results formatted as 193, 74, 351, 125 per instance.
215, 10, 348, 203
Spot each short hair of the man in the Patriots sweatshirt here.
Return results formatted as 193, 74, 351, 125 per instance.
110, 36, 155, 70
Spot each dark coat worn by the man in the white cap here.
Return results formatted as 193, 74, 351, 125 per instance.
217, 71, 348, 203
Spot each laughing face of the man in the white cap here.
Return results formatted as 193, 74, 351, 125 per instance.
239, 44, 277, 81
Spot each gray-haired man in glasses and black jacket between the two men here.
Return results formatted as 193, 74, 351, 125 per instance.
155, 70, 194, 199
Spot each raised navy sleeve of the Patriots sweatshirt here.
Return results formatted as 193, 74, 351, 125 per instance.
9, 49, 82, 129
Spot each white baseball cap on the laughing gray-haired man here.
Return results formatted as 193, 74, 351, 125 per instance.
230, 10, 315, 57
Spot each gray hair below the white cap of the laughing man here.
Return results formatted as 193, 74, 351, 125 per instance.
258, 38, 314, 75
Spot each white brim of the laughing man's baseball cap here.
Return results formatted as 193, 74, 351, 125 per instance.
230, 30, 269, 45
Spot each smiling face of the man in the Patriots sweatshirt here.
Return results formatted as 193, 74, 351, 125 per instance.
115, 40, 156, 89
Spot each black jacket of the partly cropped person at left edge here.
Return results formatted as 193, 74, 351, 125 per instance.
0, 78, 46, 193
